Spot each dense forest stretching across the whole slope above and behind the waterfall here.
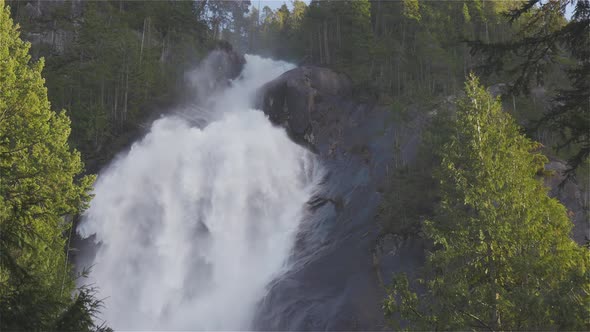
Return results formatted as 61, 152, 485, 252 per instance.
7, 0, 588, 176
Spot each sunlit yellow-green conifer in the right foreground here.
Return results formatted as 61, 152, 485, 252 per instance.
384, 76, 590, 330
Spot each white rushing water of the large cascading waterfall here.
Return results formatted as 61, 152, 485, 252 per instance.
78, 56, 321, 330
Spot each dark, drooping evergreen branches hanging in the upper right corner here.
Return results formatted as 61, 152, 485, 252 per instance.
471, 0, 590, 177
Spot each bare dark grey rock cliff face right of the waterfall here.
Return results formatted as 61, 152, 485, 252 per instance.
254, 67, 588, 330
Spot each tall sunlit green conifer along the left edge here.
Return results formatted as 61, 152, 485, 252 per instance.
0, 0, 100, 331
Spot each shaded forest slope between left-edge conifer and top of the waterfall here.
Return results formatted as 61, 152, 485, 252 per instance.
7, 1, 214, 172
